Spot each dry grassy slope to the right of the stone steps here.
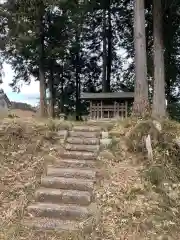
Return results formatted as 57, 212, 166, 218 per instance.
97, 119, 180, 240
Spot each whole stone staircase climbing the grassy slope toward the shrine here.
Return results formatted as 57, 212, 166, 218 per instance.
23, 126, 100, 232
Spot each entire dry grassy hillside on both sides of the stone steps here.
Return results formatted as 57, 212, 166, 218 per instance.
0, 119, 180, 240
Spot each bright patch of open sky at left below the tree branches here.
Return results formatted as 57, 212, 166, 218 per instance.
0, 64, 39, 106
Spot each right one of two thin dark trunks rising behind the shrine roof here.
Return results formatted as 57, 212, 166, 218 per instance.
106, 0, 112, 92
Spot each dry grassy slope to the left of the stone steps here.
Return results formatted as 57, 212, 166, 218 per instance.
0, 119, 68, 240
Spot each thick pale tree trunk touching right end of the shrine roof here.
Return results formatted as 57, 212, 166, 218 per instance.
133, 0, 149, 117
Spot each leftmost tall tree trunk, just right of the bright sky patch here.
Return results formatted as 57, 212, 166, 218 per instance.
39, 6, 47, 117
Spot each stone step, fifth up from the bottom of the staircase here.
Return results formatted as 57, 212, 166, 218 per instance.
47, 167, 96, 179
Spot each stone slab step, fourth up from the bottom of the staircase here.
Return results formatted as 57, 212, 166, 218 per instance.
41, 176, 94, 192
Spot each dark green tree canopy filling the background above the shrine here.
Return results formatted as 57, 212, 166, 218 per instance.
0, 0, 180, 120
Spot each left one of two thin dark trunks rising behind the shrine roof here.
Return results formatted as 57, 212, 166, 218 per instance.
102, 9, 107, 92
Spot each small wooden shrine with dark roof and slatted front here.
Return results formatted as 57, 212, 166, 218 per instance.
81, 92, 134, 119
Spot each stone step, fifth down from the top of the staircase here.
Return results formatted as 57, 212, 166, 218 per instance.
60, 150, 97, 160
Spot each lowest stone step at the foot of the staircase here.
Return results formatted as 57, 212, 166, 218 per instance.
23, 217, 81, 232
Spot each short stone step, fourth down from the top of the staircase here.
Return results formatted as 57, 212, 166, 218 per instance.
65, 144, 99, 152
